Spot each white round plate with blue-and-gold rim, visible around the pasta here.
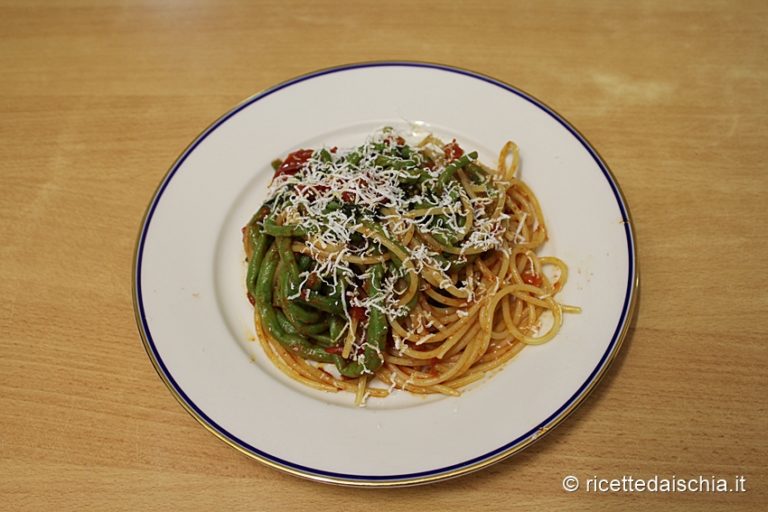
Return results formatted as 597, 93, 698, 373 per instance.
134, 62, 637, 486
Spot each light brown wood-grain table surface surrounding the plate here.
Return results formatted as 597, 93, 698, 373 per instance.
0, 0, 768, 511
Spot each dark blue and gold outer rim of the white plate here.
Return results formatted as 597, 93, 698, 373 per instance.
133, 61, 639, 487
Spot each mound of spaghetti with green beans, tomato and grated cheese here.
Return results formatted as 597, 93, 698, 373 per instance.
243, 128, 578, 405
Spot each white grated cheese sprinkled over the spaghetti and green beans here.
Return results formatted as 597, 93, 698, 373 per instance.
267, 128, 526, 374
